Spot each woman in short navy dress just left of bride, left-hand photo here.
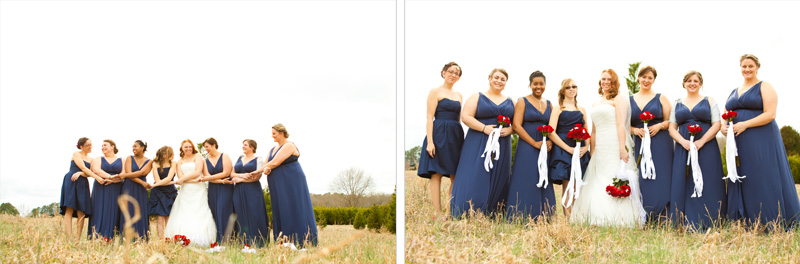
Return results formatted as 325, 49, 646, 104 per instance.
149, 146, 178, 240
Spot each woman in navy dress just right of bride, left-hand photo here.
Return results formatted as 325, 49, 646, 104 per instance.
200, 137, 236, 241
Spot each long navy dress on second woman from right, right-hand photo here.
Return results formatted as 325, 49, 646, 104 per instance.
664, 97, 727, 229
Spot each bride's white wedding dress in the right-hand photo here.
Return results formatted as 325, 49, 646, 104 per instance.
570, 103, 648, 227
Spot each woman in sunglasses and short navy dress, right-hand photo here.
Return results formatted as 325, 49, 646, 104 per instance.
547, 78, 593, 217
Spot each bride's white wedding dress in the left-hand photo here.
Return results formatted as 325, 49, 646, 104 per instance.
164, 162, 217, 247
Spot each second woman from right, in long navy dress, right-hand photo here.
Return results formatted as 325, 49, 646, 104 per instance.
664, 71, 727, 230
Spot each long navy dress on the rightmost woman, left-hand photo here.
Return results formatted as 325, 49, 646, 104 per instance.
267, 144, 317, 247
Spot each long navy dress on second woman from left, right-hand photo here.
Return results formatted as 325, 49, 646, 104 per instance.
450, 93, 514, 218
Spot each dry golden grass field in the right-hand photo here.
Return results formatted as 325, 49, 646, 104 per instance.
405, 171, 800, 263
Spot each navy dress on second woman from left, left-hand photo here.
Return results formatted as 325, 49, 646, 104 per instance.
88, 157, 122, 239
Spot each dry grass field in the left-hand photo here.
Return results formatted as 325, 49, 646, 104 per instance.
0, 215, 397, 263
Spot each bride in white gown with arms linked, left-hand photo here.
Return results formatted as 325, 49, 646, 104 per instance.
164, 139, 217, 247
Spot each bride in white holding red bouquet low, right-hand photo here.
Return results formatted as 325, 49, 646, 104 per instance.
570, 69, 645, 227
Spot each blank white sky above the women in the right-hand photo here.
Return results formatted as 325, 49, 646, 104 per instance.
405, 1, 800, 149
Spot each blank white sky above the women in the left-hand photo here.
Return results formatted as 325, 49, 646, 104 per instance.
0, 1, 397, 212
